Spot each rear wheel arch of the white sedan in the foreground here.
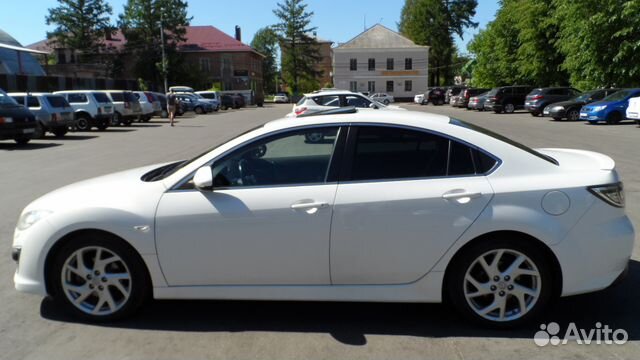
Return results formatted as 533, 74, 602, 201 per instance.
442, 230, 563, 302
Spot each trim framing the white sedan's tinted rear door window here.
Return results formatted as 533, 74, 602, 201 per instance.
338, 123, 502, 184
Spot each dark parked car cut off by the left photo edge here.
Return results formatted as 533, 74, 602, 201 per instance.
0, 89, 38, 145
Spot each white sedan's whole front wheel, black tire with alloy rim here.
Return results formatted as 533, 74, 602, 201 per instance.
49, 232, 151, 322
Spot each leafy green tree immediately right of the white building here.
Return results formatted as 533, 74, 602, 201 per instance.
398, 0, 478, 85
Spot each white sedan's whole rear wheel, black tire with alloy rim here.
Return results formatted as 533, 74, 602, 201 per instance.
445, 238, 555, 328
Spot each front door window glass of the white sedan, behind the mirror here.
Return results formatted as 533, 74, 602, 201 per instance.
212, 127, 339, 188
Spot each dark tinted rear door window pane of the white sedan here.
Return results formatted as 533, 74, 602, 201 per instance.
351, 126, 449, 180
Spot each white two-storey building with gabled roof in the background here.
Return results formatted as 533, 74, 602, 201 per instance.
333, 24, 429, 100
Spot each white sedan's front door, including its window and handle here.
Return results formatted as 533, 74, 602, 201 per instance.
156, 127, 339, 286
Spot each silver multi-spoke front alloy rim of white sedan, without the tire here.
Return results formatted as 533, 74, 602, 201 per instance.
60, 246, 132, 316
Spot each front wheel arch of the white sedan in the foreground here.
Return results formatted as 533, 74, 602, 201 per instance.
44, 229, 153, 295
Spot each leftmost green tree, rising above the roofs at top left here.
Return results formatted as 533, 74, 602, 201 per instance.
45, 0, 115, 61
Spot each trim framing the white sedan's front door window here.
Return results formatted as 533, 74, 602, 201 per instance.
166, 123, 348, 193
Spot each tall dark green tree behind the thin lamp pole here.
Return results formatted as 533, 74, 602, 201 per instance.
118, 0, 191, 84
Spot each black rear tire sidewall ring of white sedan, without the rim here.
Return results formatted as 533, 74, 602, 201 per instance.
445, 238, 555, 329
